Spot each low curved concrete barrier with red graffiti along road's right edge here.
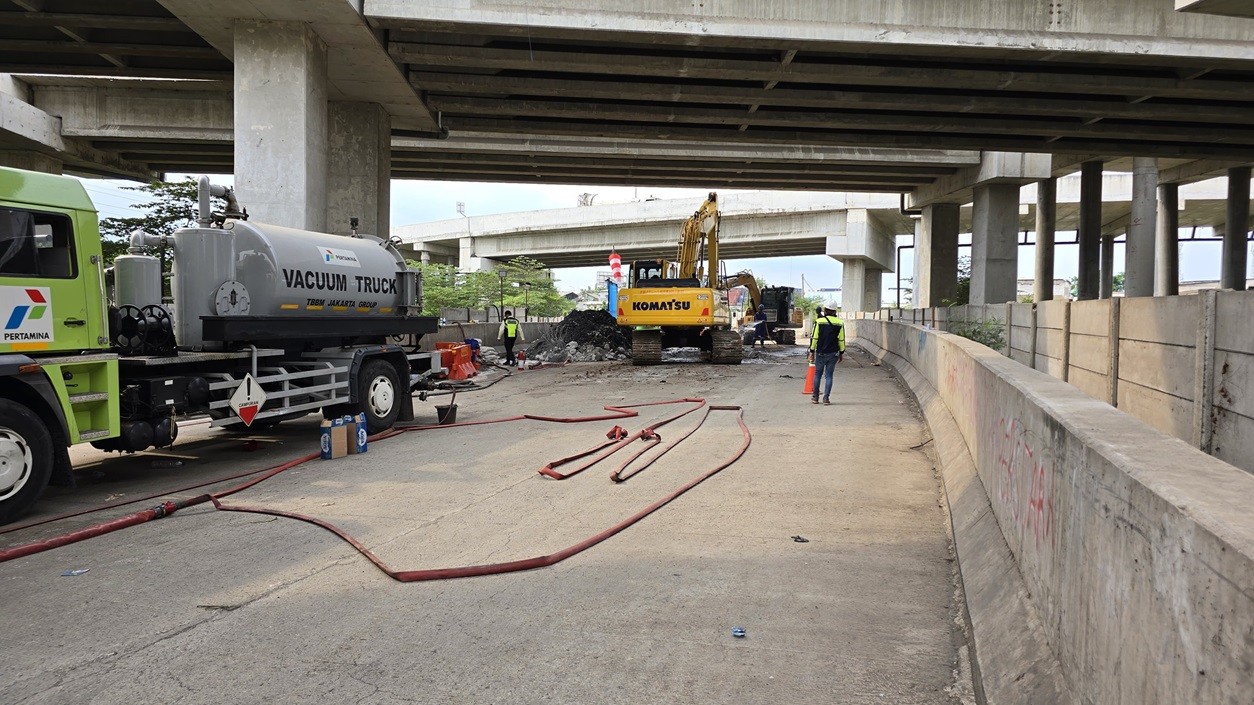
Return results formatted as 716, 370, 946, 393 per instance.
850, 318, 1254, 705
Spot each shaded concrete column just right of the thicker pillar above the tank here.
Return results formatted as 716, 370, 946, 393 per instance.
326, 102, 391, 237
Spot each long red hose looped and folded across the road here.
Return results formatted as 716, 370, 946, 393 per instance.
0, 398, 752, 582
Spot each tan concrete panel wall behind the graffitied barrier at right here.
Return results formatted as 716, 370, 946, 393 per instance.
874, 291, 1254, 473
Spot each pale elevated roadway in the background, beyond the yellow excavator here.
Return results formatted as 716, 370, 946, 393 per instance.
393, 173, 1243, 271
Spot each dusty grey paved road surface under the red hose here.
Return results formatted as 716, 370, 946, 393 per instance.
0, 349, 964, 705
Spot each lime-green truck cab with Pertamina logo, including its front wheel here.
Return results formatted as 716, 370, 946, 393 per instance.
0, 168, 119, 523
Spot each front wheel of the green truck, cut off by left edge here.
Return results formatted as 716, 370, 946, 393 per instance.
0, 399, 53, 524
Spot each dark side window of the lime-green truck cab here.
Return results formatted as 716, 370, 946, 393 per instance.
0, 207, 75, 278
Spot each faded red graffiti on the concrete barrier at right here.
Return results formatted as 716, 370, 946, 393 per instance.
993, 416, 1053, 548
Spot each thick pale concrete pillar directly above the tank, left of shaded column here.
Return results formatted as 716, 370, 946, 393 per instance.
234, 20, 327, 231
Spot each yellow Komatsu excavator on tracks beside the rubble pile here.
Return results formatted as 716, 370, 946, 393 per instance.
618, 192, 744, 365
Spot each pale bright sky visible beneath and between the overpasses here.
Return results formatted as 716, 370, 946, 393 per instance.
80, 174, 1254, 305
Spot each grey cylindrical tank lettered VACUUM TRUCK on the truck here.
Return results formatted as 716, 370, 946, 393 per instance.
173, 221, 406, 350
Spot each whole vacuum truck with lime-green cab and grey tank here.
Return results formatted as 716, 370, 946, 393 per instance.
0, 168, 438, 524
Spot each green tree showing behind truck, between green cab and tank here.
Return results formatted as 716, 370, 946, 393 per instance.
100, 177, 226, 296
